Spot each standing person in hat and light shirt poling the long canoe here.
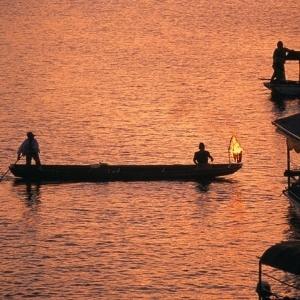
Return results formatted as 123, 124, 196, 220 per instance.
17, 131, 41, 166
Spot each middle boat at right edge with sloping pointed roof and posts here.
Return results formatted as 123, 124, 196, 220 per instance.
273, 114, 300, 216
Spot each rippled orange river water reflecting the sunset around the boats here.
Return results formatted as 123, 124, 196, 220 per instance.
0, 0, 300, 299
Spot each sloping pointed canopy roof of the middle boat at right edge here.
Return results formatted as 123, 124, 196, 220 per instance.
272, 113, 300, 153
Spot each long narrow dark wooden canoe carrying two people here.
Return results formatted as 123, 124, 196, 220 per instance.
9, 163, 242, 182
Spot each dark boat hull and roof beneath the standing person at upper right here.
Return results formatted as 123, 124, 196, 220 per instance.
263, 51, 300, 97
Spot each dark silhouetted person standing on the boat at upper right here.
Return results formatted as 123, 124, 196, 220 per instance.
271, 41, 291, 81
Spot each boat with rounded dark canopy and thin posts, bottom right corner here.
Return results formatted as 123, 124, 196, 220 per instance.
256, 241, 300, 300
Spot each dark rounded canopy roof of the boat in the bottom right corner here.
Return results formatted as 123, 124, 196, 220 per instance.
260, 241, 300, 275
